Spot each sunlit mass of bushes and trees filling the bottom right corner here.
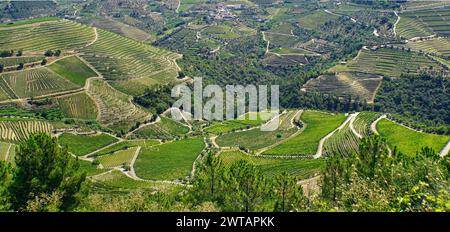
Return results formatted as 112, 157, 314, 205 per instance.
321, 136, 450, 211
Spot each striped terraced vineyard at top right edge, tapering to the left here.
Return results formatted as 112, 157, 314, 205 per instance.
400, 6, 450, 36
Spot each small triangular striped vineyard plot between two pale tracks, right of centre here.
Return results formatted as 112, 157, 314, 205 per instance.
323, 119, 359, 156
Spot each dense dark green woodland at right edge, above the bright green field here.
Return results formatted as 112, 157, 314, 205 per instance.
375, 74, 450, 134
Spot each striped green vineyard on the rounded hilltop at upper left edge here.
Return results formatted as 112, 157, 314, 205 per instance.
0, 20, 95, 52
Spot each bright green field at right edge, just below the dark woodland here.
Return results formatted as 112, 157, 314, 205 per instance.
377, 119, 450, 155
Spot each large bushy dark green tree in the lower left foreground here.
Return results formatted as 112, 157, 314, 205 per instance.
8, 133, 86, 211
